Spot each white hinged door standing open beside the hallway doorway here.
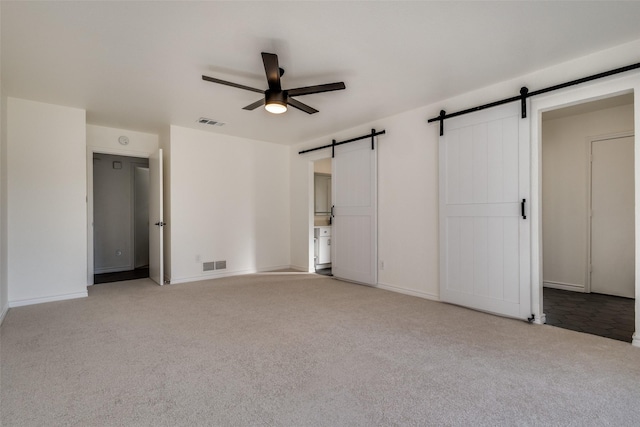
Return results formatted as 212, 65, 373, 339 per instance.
149, 149, 164, 285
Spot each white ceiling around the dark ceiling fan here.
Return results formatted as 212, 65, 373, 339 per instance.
0, 0, 640, 144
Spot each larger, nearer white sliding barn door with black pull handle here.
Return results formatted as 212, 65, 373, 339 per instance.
439, 102, 532, 319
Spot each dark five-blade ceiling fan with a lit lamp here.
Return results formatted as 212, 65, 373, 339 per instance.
202, 52, 345, 114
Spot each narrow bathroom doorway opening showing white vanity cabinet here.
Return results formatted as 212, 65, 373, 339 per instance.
313, 158, 333, 276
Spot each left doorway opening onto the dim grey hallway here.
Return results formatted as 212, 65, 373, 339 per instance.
93, 153, 149, 284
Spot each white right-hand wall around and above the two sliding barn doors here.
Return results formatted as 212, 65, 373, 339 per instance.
291, 40, 640, 299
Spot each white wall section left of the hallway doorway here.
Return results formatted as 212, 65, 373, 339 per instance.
7, 98, 87, 307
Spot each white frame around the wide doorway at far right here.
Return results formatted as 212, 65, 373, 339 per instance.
530, 72, 640, 347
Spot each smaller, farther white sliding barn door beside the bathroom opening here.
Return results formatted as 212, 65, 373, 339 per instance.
331, 139, 378, 285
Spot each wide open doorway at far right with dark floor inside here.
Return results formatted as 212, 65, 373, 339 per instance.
541, 93, 635, 342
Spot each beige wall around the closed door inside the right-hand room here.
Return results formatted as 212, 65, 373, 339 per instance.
542, 104, 633, 291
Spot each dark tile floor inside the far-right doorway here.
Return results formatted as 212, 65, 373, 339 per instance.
543, 288, 635, 342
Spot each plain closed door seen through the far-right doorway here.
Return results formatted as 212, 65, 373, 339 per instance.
591, 136, 635, 298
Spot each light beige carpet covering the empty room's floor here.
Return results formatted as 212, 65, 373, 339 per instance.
0, 274, 640, 426
